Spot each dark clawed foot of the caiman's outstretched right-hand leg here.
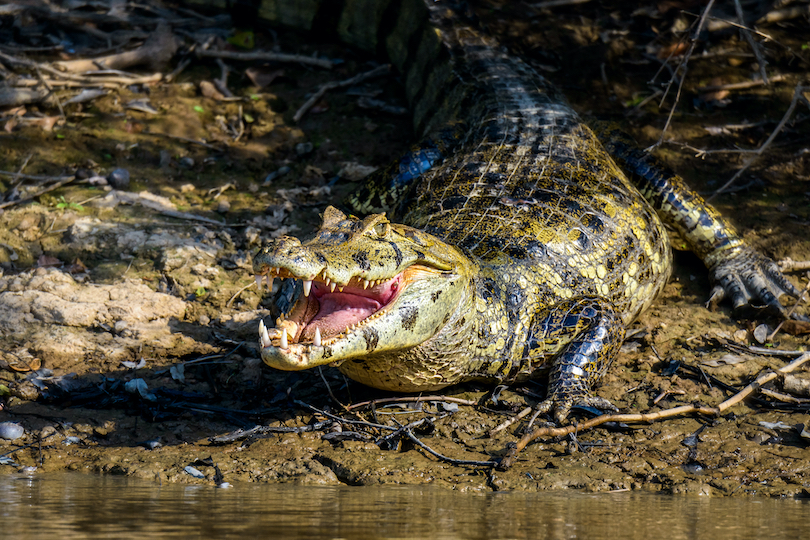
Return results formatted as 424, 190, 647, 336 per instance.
708, 246, 801, 317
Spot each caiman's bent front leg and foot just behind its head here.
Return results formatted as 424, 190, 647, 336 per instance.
529, 297, 625, 422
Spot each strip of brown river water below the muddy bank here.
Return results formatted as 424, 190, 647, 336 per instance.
0, 473, 808, 540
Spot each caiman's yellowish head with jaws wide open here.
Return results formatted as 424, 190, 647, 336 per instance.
253, 206, 473, 380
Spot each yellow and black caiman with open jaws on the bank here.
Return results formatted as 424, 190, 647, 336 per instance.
249, 0, 798, 421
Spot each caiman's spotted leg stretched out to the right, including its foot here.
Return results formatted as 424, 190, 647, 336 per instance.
593, 123, 801, 316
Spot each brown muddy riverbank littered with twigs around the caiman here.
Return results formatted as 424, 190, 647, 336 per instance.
0, 2, 810, 497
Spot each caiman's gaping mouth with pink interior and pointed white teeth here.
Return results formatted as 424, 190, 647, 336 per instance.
256, 268, 405, 349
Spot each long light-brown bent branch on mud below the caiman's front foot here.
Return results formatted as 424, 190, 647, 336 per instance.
498, 353, 810, 469
